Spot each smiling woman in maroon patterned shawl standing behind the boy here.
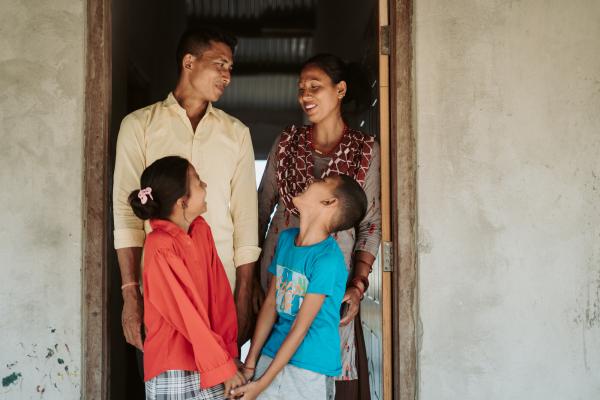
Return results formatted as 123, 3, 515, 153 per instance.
258, 54, 381, 399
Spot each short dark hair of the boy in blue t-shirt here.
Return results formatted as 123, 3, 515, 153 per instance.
330, 175, 367, 233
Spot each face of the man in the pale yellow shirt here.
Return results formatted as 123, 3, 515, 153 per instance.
187, 42, 233, 102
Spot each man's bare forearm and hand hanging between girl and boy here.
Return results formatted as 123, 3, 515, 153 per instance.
233, 263, 255, 346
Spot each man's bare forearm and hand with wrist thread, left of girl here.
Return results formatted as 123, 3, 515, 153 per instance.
117, 247, 143, 350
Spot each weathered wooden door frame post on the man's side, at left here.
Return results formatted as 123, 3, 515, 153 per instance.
81, 0, 112, 400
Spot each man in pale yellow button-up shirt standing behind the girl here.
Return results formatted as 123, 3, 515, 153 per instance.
113, 28, 260, 349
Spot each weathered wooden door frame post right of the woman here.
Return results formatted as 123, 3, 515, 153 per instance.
389, 0, 418, 400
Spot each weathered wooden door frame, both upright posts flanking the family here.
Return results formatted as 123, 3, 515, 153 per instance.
81, 0, 417, 400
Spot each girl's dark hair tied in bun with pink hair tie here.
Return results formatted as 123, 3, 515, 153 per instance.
129, 156, 190, 219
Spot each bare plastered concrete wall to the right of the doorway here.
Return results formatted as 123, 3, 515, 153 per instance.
414, 0, 600, 400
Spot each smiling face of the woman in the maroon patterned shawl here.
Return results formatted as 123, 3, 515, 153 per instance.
298, 64, 346, 124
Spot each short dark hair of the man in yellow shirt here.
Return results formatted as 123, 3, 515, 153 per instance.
176, 26, 237, 71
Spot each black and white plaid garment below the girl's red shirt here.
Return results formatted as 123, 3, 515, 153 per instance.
146, 370, 225, 400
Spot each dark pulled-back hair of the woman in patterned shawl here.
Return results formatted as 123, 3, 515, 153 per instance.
300, 53, 371, 112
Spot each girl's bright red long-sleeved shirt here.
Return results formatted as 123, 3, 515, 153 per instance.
143, 217, 238, 388
